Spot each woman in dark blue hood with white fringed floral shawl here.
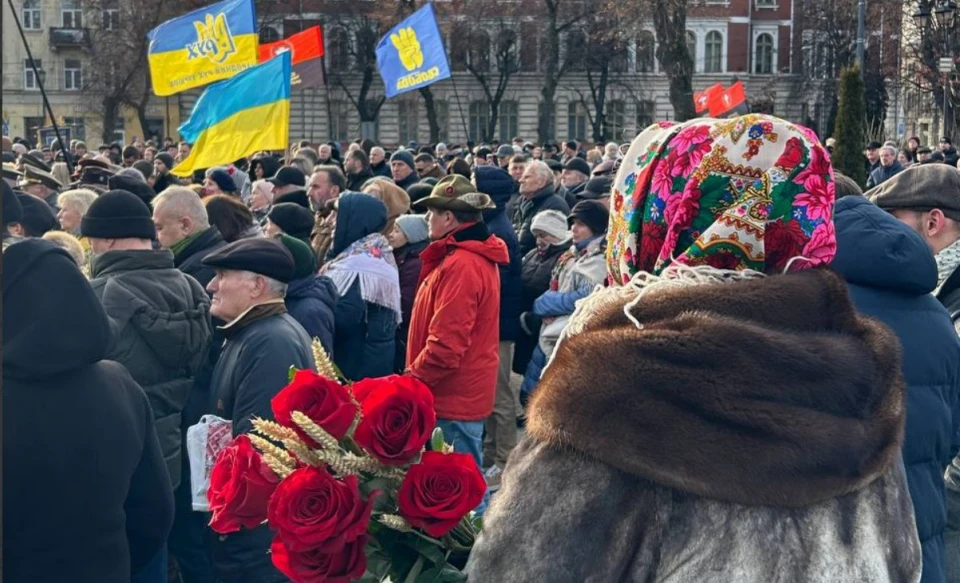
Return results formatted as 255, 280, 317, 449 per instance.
320, 192, 400, 381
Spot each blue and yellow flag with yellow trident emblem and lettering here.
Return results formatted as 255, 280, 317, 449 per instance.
147, 0, 259, 97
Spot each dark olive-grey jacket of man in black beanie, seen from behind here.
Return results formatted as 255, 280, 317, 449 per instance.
90, 250, 212, 488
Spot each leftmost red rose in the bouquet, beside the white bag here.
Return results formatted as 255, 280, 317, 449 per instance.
207, 435, 280, 534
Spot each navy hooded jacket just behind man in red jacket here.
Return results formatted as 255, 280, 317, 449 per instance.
474, 166, 523, 342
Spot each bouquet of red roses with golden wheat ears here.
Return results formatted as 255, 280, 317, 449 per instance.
207, 344, 486, 583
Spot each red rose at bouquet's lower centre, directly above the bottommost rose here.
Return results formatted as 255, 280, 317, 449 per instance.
267, 466, 379, 553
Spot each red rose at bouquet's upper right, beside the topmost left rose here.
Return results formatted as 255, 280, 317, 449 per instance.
352, 375, 437, 466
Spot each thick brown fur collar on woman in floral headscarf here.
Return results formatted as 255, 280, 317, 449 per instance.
528, 270, 904, 507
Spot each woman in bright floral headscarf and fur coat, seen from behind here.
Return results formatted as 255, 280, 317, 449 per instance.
467, 115, 921, 583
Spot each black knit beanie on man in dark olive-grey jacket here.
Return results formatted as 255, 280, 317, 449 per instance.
80, 190, 157, 239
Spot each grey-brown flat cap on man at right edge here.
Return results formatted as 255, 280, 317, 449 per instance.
864, 164, 960, 218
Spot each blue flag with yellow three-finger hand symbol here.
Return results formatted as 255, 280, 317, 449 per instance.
377, 4, 450, 97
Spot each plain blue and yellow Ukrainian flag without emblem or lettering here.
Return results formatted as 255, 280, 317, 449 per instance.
171, 51, 291, 176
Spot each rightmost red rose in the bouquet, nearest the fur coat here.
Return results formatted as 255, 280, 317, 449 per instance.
397, 451, 487, 537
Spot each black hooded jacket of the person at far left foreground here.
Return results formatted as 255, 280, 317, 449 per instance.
3, 239, 173, 583
